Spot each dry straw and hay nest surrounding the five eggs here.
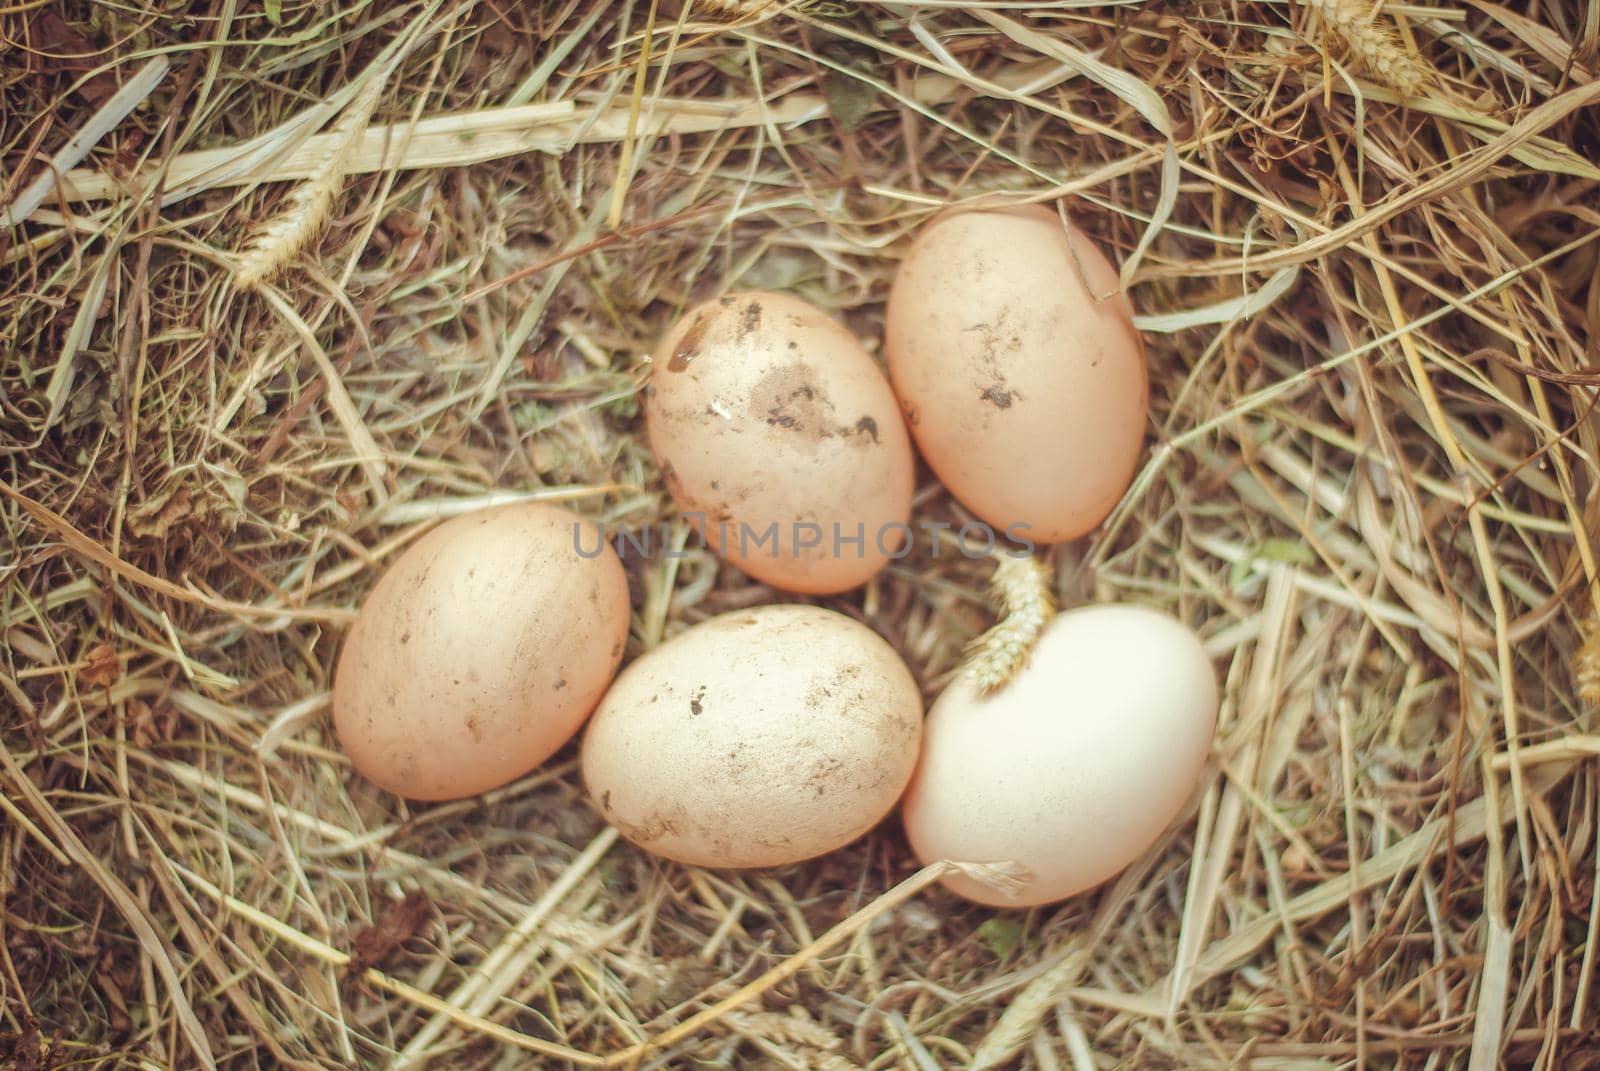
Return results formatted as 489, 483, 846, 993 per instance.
0, 0, 1600, 1071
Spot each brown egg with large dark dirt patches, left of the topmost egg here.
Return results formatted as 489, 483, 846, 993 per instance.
645, 291, 912, 594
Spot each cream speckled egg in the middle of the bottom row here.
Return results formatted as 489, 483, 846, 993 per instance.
582, 605, 922, 868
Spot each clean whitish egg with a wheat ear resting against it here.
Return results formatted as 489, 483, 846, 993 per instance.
901, 605, 1218, 908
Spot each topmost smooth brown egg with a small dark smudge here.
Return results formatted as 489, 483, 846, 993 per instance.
885, 207, 1149, 543
